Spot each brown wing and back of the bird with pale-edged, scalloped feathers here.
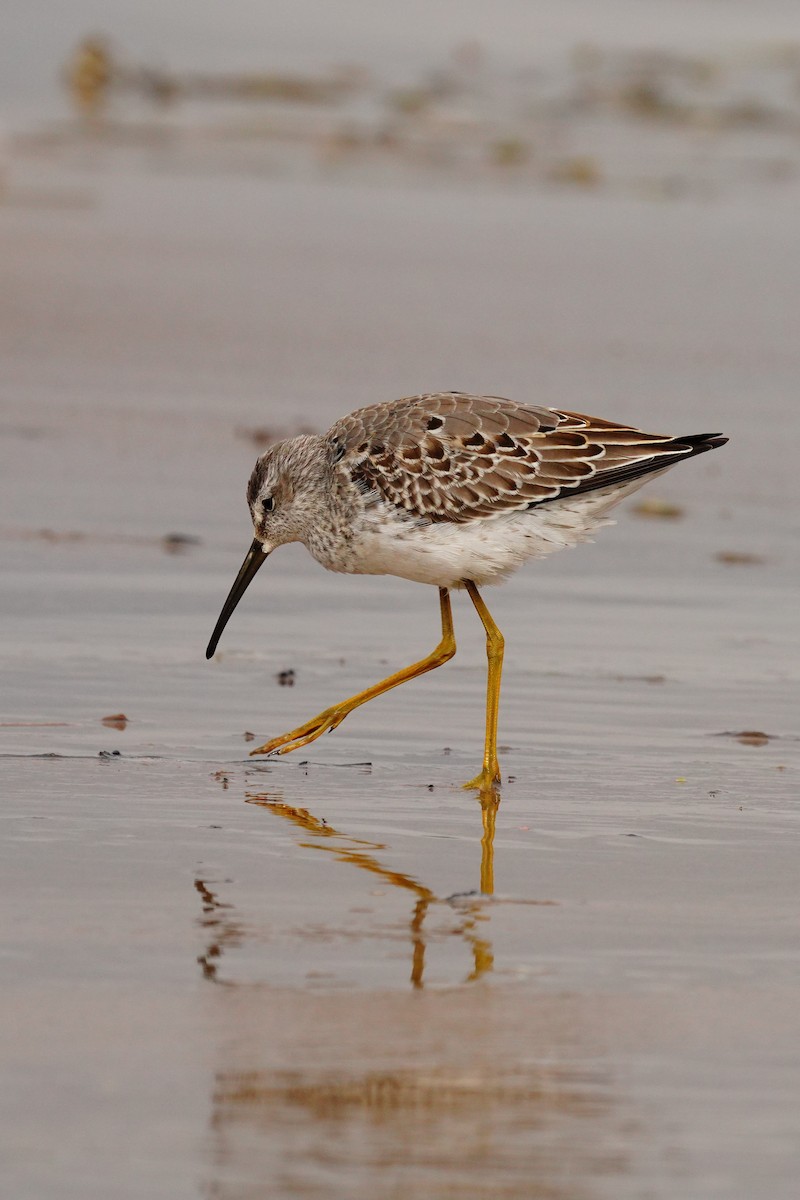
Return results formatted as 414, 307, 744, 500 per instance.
327, 392, 714, 522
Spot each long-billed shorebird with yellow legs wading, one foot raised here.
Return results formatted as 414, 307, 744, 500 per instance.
206, 391, 728, 796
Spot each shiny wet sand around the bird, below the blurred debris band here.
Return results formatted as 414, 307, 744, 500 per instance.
0, 79, 800, 1200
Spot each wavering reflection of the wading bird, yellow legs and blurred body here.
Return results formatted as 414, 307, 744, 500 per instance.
194, 791, 626, 1200
